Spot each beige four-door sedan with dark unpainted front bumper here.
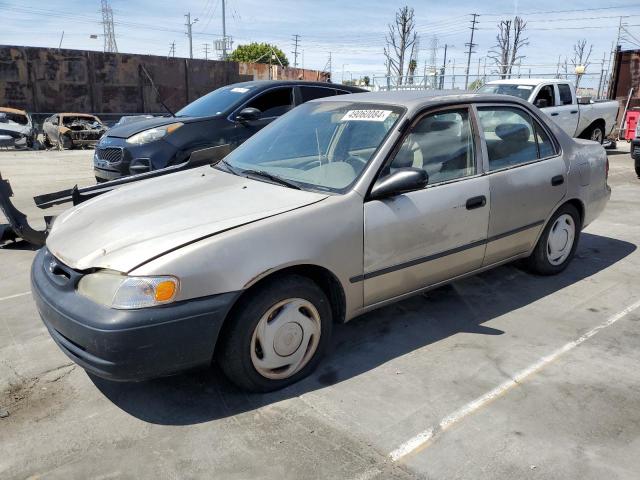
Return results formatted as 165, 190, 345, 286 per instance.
31, 91, 611, 391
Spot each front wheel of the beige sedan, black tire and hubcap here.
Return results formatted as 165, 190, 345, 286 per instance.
216, 275, 333, 392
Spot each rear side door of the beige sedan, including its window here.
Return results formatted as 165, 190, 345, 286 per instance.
478, 106, 567, 265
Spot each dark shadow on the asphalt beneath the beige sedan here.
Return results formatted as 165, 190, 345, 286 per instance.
90, 233, 637, 425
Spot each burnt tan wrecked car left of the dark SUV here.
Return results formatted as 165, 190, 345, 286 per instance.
42, 113, 107, 150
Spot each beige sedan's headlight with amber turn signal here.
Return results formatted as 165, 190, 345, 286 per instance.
78, 272, 180, 310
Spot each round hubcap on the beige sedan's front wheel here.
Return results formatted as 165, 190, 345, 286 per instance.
251, 298, 321, 380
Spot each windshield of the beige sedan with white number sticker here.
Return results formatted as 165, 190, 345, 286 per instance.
221, 102, 403, 192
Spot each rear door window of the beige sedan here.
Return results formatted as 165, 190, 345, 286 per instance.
478, 107, 555, 170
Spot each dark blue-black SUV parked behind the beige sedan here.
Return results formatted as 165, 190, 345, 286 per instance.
93, 80, 366, 182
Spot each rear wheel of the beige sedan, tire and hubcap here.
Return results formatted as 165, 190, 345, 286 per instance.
526, 204, 582, 275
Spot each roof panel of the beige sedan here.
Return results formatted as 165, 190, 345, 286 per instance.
312, 90, 529, 110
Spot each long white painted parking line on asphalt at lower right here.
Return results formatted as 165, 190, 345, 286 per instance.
389, 300, 640, 462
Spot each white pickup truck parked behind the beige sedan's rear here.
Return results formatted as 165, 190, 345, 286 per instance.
478, 78, 618, 143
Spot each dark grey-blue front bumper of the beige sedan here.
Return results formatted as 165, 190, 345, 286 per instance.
31, 248, 239, 381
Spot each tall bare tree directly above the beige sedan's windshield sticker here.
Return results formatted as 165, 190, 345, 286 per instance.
384, 6, 418, 85
